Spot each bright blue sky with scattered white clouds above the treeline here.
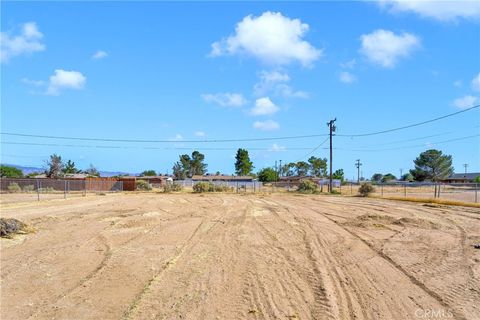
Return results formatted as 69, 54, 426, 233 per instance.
1, 1, 480, 178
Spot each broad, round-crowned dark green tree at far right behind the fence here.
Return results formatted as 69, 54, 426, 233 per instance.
410, 149, 453, 181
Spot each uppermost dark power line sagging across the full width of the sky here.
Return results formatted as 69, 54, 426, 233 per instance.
0, 105, 480, 143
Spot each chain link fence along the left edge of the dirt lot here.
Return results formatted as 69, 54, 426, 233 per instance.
0, 178, 123, 203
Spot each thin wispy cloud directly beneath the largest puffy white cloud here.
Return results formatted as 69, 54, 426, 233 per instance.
253, 70, 308, 98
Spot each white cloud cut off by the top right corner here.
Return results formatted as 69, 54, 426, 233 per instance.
379, 0, 480, 21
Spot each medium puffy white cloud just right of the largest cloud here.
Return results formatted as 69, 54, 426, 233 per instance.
360, 29, 420, 68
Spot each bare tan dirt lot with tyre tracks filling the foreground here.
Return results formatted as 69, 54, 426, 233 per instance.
0, 194, 480, 320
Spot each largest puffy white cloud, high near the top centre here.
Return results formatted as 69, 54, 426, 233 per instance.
210, 11, 322, 66
